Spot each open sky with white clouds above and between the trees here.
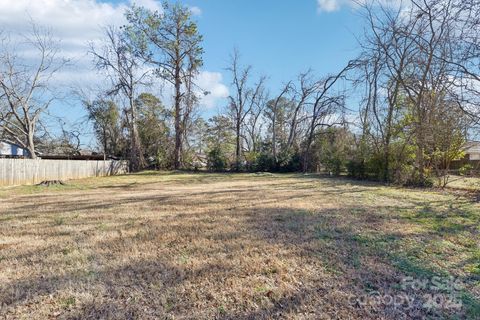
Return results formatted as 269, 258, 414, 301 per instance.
0, 0, 362, 144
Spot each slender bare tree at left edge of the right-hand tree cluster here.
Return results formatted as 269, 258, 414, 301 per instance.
360, 5, 414, 181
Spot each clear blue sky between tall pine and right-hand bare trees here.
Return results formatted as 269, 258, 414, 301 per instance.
186, 0, 361, 91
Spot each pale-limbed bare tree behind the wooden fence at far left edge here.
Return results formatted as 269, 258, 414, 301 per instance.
0, 24, 67, 159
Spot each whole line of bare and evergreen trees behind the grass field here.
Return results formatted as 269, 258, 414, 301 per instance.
0, 0, 480, 186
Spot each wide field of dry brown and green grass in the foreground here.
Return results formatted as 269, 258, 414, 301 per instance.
0, 172, 480, 319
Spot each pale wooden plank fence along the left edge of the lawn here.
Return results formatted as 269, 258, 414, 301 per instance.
0, 159, 128, 186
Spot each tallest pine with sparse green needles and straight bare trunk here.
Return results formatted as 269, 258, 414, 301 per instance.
125, 2, 203, 169
